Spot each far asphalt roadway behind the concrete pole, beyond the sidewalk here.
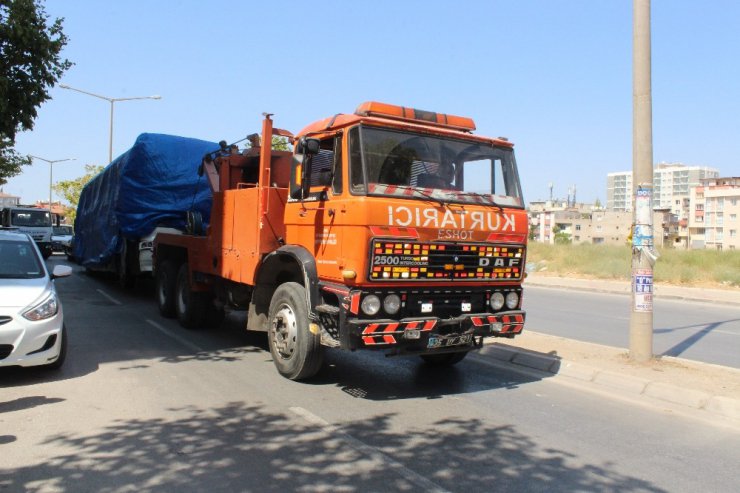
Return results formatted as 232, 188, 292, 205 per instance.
524, 286, 740, 368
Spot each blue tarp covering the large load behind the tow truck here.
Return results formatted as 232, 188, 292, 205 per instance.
73, 133, 219, 268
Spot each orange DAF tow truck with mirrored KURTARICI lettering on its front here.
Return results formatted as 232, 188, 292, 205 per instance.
154, 102, 528, 380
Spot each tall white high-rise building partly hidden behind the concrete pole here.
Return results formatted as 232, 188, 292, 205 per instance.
606, 163, 719, 214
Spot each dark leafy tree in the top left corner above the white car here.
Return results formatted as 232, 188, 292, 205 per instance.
0, 0, 72, 185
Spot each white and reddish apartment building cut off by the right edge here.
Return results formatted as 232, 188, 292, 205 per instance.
688, 177, 740, 250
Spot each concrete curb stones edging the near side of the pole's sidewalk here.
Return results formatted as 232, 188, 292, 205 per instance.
485, 346, 740, 421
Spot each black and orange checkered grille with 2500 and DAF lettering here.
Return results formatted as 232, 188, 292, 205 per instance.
368, 239, 525, 281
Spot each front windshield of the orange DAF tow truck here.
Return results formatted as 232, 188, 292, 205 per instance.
350, 126, 524, 207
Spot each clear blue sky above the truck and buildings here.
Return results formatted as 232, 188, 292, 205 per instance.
3, 0, 740, 203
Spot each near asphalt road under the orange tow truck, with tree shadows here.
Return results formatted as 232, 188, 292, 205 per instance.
0, 257, 740, 493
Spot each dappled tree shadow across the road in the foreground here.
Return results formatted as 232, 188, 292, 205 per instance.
0, 403, 662, 493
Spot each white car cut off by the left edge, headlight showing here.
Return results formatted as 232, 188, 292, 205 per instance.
0, 230, 72, 369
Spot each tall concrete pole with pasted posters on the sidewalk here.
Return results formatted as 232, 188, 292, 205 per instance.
630, 0, 655, 362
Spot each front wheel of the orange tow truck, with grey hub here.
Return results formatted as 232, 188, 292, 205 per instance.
267, 282, 324, 380
